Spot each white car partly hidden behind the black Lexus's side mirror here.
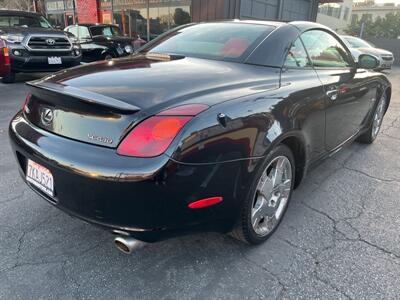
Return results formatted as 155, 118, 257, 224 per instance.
341, 35, 394, 70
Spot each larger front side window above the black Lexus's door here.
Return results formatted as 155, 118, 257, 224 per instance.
301, 30, 351, 68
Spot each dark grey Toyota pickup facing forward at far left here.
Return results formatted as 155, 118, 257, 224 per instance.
0, 10, 81, 83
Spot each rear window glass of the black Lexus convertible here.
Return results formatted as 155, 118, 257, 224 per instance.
141, 22, 275, 61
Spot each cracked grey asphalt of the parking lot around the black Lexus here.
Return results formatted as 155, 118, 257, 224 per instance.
0, 68, 400, 299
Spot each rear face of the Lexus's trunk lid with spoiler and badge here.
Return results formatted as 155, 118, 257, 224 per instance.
24, 81, 140, 148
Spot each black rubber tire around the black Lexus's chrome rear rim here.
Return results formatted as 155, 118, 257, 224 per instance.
229, 145, 295, 245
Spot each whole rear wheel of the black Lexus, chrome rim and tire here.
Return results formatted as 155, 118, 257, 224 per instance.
231, 145, 295, 244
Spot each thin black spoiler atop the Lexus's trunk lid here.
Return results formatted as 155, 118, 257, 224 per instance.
26, 80, 140, 112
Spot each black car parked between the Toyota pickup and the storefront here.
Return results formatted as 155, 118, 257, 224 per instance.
64, 24, 145, 62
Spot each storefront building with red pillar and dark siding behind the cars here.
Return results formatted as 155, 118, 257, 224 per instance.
45, 0, 318, 39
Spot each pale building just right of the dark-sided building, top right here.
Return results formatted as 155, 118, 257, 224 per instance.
317, 0, 353, 33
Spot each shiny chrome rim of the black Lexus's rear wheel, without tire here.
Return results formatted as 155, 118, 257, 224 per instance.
251, 156, 292, 236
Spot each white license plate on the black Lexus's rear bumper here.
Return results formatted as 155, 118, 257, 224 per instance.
26, 159, 54, 197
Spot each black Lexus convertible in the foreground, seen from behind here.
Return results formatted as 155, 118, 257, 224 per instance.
9, 21, 391, 253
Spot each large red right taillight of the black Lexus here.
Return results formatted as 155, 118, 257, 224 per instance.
117, 104, 208, 157
